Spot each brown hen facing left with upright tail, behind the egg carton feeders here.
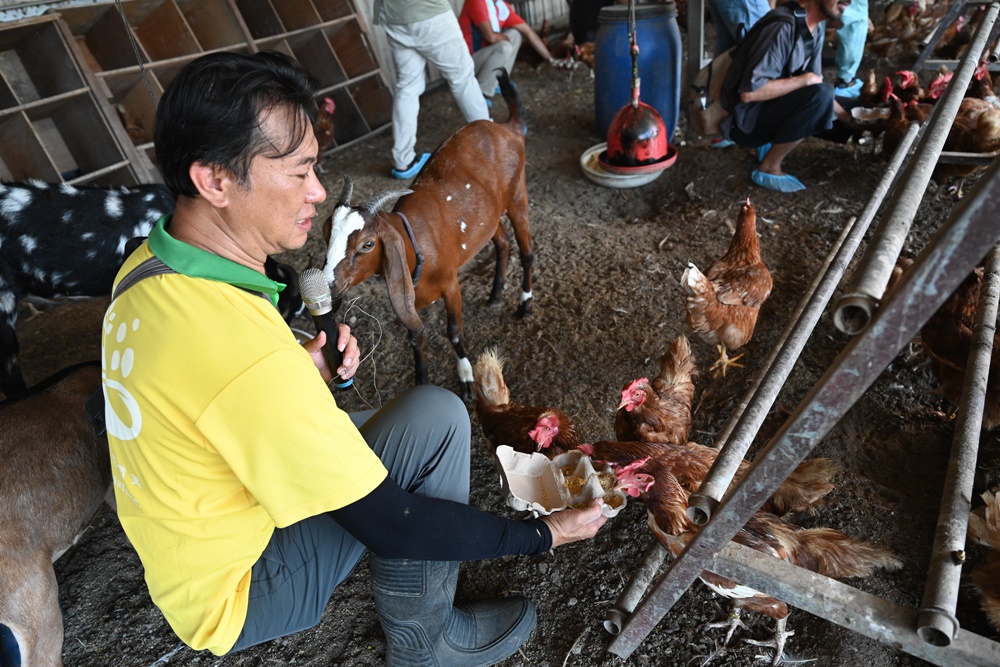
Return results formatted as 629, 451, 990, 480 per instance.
615, 335, 697, 445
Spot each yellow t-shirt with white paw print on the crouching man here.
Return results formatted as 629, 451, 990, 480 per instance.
102, 244, 387, 655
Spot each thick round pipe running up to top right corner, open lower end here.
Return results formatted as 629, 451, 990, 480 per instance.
834, 3, 1000, 335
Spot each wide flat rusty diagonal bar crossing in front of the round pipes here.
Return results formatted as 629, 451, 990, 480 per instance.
608, 158, 1000, 658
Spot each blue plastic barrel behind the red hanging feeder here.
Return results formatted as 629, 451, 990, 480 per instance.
594, 2, 681, 142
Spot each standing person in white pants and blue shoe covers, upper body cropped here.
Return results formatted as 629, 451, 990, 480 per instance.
373, 0, 490, 178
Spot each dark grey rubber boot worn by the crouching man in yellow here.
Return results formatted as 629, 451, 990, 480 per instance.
368, 553, 536, 667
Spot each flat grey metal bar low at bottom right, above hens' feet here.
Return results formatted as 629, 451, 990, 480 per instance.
705, 542, 1000, 667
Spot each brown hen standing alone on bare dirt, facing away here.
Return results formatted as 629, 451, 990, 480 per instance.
681, 198, 772, 376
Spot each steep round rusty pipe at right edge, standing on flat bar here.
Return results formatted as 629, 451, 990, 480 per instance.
917, 246, 1000, 646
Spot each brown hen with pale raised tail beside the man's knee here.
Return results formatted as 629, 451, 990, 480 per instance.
472, 350, 580, 458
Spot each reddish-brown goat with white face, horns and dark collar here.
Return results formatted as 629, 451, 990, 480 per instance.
323, 69, 533, 398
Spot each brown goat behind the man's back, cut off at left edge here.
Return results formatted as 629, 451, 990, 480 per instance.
0, 362, 114, 667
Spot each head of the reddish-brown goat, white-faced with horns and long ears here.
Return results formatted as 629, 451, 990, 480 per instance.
323, 175, 423, 331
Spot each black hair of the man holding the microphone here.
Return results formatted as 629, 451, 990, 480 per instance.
154, 51, 317, 197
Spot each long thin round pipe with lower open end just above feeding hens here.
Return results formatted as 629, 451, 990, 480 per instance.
687, 124, 919, 526
